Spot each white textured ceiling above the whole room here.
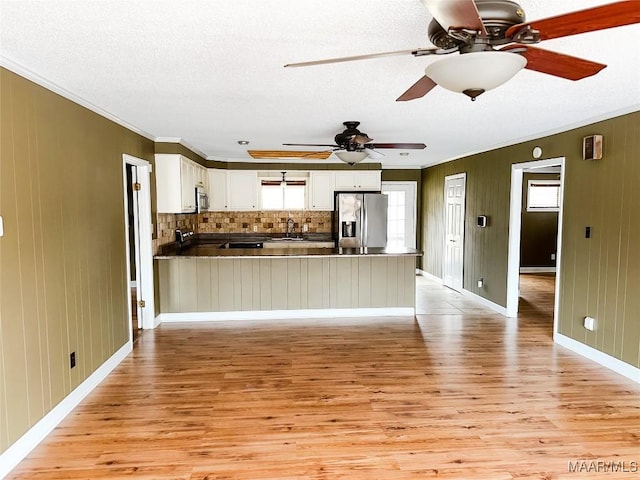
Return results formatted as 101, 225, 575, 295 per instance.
0, 0, 640, 168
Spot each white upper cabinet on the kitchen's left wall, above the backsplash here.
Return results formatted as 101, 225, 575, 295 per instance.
155, 153, 201, 213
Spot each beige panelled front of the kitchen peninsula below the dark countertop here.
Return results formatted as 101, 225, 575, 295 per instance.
156, 256, 416, 313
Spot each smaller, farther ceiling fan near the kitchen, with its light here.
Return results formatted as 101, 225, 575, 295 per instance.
283, 121, 426, 165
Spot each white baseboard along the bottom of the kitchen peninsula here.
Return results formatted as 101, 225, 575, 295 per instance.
156, 307, 416, 323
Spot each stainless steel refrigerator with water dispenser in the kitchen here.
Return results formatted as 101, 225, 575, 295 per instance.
334, 192, 389, 248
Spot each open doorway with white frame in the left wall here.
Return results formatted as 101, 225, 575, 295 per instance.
123, 154, 156, 334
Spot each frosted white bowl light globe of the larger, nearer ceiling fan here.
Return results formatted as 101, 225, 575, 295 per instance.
425, 51, 527, 93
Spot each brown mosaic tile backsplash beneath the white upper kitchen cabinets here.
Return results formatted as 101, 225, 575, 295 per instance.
153, 210, 332, 253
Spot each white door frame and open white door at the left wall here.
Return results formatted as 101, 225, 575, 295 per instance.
122, 153, 158, 330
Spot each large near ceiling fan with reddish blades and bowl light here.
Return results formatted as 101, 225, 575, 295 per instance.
285, 0, 640, 101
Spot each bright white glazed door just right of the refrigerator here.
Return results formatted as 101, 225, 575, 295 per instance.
382, 182, 417, 248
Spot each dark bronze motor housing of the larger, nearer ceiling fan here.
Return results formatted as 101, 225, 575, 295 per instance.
427, 0, 526, 49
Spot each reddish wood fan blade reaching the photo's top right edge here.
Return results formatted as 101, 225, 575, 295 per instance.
504, 0, 640, 40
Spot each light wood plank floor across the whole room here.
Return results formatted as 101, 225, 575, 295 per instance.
8, 276, 640, 480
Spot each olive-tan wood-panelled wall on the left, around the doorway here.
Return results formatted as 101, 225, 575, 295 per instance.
0, 68, 153, 451
